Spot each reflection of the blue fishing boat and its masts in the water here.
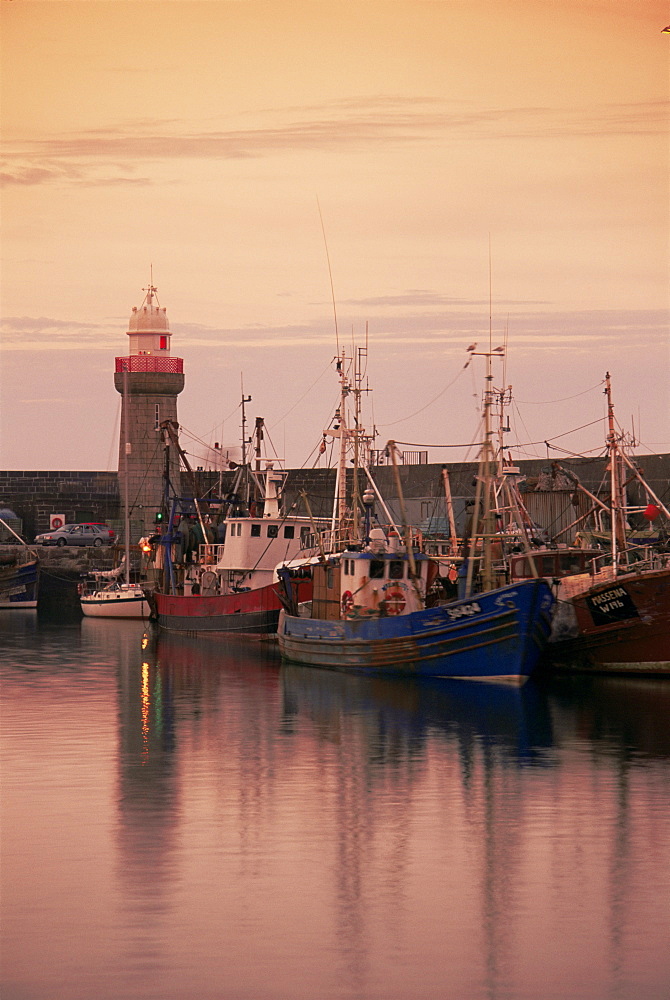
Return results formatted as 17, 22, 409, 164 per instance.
282, 666, 551, 995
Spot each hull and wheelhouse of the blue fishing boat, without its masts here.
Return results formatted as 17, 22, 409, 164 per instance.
277, 551, 554, 684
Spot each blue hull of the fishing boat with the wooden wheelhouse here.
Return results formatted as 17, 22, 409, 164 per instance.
277, 580, 554, 684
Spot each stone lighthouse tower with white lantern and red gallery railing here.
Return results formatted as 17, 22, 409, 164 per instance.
114, 280, 184, 540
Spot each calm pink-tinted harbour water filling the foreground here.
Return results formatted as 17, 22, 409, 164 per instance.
0, 612, 670, 1000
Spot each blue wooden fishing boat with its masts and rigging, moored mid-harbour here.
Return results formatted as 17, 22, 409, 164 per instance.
276, 352, 555, 684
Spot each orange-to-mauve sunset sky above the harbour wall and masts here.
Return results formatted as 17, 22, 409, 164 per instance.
0, 0, 670, 470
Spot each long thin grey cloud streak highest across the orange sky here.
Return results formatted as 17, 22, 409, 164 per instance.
2, 98, 668, 185
